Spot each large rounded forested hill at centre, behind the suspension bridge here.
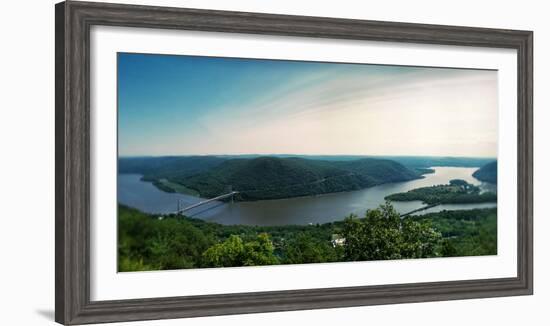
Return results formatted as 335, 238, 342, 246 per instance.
173, 157, 419, 200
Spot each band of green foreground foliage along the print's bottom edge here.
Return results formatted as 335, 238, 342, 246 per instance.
118, 204, 497, 272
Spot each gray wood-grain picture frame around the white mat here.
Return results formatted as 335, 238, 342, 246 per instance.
55, 1, 533, 324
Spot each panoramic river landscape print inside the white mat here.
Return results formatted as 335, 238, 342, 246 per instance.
117, 53, 498, 272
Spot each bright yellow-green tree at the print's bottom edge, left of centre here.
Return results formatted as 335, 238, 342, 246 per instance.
203, 233, 278, 267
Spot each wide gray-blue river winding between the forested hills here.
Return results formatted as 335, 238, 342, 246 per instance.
118, 167, 496, 225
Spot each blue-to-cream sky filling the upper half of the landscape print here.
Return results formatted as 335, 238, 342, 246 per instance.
118, 53, 498, 157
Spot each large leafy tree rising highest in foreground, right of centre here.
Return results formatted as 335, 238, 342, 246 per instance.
342, 202, 441, 261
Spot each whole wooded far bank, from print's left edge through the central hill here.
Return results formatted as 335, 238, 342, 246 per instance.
119, 156, 421, 200
